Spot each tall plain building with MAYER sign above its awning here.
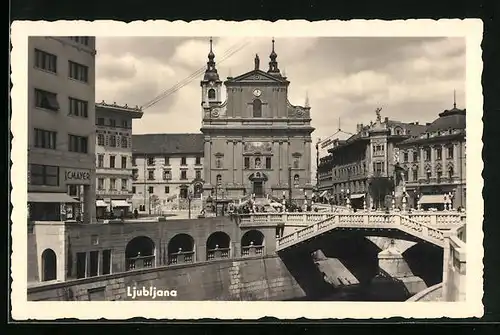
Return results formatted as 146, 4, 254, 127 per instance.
28, 36, 96, 223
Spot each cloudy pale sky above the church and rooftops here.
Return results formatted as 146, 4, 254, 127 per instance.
96, 37, 465, 177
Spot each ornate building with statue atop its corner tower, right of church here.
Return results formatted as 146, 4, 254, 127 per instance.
318, 109, 425, 207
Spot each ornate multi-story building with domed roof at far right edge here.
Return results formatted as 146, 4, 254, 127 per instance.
398, 104, 466, 209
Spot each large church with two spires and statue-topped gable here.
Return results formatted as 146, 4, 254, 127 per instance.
201, 40, 314, 203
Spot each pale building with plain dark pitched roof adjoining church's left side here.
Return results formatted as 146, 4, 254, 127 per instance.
132, 134, 204, 214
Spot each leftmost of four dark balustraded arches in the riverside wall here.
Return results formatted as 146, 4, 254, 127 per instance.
125, 236, 155, 271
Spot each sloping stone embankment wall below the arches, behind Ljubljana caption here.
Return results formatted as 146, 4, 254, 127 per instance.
28, 256, 305, 301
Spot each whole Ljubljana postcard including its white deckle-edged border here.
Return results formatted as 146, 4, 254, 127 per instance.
11, 20, 483, 319
